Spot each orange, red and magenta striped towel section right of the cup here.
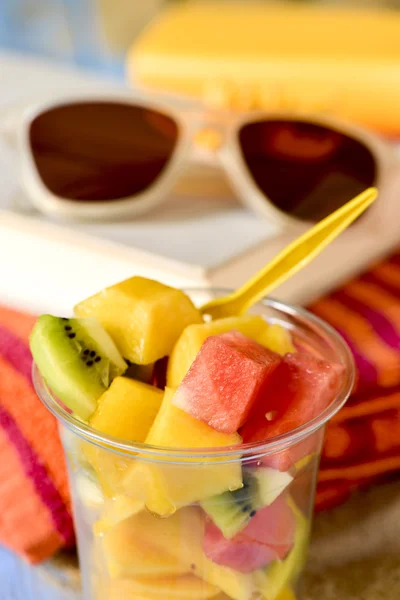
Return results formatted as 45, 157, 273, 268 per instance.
309, 252, 400, 510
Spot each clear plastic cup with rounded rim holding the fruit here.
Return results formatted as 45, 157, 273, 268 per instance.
34, 290, 354, 600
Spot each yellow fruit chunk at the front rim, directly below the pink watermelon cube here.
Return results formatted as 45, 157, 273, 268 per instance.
121, 388, 242, 515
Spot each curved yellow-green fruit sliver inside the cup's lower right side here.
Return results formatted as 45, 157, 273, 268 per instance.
254, 499, 310, 600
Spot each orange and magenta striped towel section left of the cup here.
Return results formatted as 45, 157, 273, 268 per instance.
0, 308, 74, 563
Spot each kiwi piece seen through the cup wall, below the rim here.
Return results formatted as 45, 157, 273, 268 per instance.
200, 467, 293, 539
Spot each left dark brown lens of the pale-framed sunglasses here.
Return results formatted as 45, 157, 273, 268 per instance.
29, 102, 178, 201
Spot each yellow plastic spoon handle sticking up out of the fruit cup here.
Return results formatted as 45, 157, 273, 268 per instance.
200, 188, 378, 319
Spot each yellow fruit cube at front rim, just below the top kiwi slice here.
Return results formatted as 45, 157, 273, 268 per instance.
82, 377, 163, 497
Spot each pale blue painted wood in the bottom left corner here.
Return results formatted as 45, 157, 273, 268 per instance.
0, 546, 80, 600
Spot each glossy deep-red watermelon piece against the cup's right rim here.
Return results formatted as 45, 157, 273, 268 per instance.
239, 352, 344, 470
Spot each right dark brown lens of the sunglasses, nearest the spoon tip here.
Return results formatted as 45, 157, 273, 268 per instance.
239, 120, 377, 221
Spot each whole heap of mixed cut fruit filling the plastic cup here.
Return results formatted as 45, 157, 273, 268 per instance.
30, 277, 345, 600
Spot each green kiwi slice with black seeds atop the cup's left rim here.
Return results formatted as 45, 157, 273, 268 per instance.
30, 315, 127, 421
